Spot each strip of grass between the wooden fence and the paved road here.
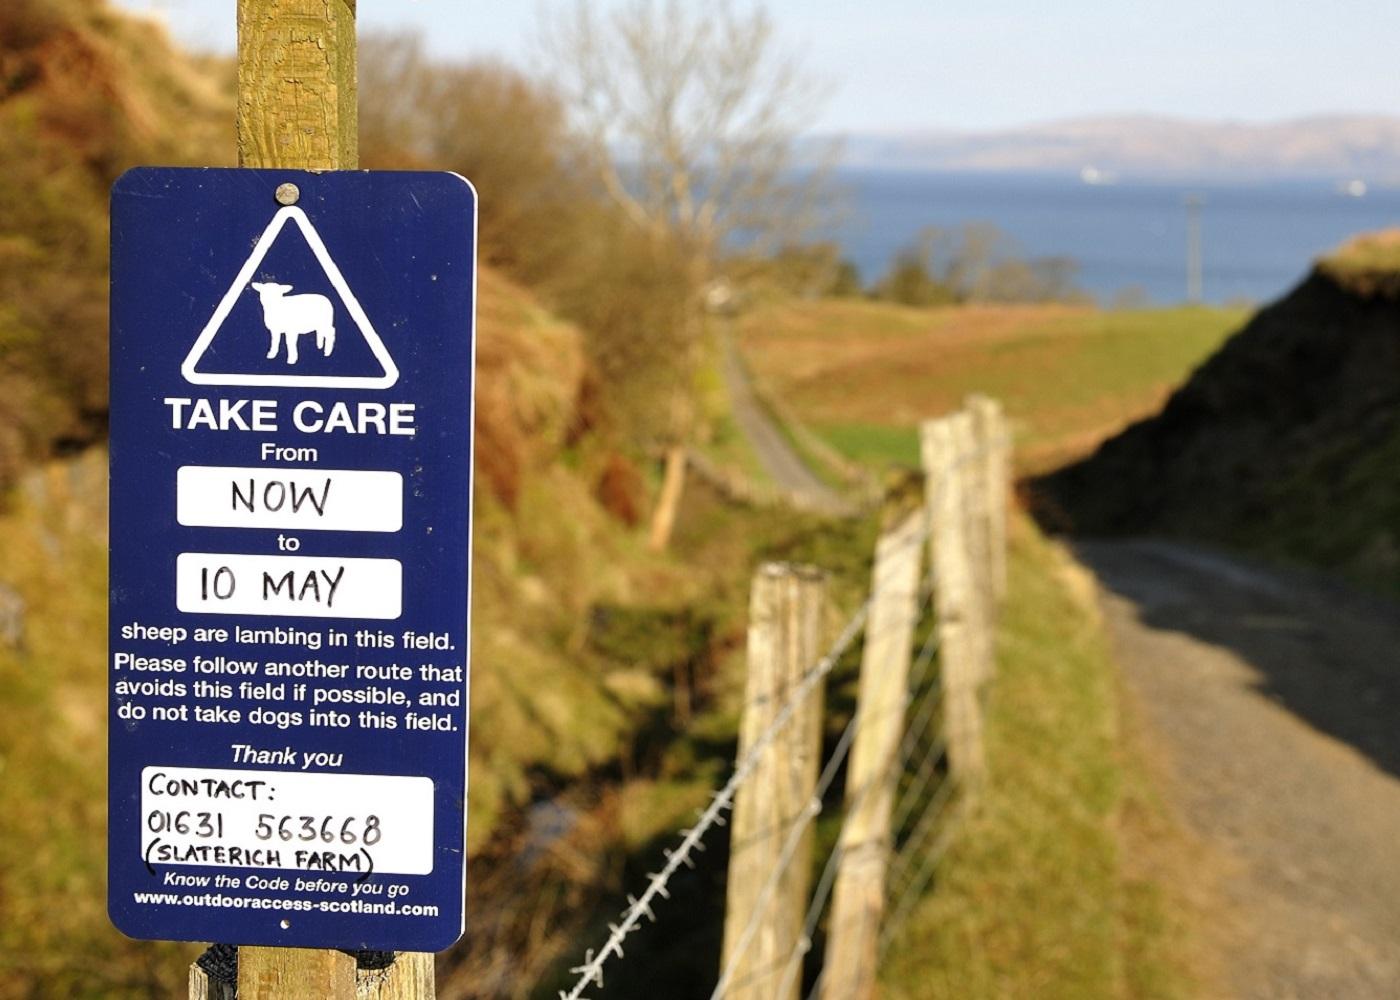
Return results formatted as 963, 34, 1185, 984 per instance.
882, 520, 1197, 1000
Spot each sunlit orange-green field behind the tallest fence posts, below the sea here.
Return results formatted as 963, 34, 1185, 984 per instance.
741, 300, 1246, 469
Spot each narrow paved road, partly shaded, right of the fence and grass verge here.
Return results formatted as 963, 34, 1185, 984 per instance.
1077, 541, 1400, 1000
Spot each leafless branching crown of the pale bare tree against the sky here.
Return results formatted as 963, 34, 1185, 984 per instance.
545, 0, 825, 275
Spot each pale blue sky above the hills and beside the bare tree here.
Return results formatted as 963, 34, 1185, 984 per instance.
116, 0, 1400, 132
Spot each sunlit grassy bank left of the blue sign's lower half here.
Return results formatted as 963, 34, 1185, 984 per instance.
0, 451, 194, 997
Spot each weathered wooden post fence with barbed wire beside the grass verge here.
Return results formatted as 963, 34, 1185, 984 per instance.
560, 396, 1011, 1000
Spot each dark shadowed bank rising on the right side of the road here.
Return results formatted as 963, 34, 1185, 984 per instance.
1032, 245, 1400, 588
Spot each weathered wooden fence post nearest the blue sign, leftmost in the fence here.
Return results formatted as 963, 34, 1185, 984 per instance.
721, 563, 826, 1000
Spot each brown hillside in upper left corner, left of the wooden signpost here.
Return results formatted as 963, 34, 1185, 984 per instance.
0, 0, 232, 485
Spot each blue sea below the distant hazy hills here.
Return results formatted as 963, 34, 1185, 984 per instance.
834, 169, 1400, 304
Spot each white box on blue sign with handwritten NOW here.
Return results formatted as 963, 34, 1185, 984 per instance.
176, 465, 403, 531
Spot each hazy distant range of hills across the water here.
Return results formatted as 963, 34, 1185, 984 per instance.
823, 115, 1400, 183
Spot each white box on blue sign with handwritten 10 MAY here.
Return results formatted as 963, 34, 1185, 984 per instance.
175, 552, 403, 619
